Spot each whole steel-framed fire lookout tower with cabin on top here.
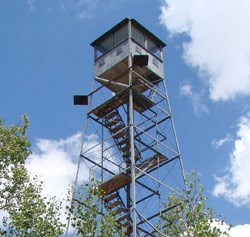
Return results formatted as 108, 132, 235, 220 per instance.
72, 18, 184, 237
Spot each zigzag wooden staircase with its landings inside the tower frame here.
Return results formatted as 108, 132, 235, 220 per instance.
89, 85, 167, 236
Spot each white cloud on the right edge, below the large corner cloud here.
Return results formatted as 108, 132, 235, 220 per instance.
213, 114, 250, 207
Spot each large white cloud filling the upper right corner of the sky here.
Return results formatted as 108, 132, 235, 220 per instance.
160, 0, 250, 101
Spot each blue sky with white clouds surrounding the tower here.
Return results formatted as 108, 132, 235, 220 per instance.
0, 0, 250, 237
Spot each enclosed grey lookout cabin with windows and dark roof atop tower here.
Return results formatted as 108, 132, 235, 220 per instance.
91, 18, 166, 93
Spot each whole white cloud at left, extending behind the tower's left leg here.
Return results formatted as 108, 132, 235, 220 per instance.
26, 133, 119, 199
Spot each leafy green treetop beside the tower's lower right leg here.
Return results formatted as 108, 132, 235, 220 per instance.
159, 171, 230, 237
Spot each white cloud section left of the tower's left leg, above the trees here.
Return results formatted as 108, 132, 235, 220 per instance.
26, 133, 81, 198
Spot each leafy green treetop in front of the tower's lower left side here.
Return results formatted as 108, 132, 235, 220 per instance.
69, 182, 125, 237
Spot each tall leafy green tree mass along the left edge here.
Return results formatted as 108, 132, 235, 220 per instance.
0, 116, 64, 237
